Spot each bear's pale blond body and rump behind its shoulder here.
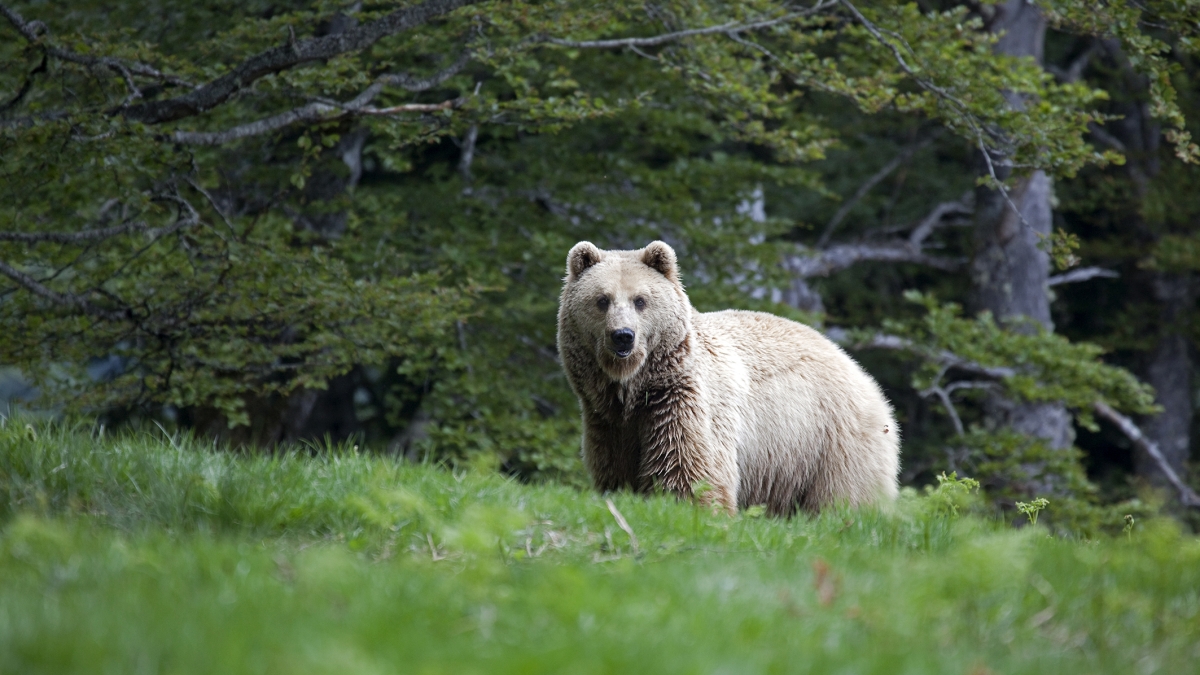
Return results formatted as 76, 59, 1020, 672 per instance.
692, 310, 899, 513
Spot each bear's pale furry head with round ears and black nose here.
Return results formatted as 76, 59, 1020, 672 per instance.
559, 241, 691, 381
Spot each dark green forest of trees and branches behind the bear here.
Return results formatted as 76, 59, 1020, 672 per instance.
0, 0, 1200, 532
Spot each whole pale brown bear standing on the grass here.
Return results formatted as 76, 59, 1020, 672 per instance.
558, 241, 900, 515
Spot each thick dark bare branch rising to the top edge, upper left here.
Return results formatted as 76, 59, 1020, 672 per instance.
119, 0, 480, 124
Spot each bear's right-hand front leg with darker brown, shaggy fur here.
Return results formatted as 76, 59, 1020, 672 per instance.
638, 383, 738, 513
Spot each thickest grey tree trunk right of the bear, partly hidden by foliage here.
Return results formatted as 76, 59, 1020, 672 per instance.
971, 0, 1075, 461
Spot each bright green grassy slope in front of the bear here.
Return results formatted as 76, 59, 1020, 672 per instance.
0, 420, 1200, 675
